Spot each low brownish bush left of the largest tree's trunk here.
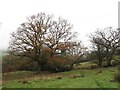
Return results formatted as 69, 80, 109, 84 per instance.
2, 55, 38, 73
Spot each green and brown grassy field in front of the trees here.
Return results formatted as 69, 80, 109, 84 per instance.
3, 67, 118, 88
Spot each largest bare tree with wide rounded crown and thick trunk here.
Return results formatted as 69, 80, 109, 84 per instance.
10, 13, 83, 71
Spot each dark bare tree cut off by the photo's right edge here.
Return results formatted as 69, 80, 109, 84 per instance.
92, 27, 120, 66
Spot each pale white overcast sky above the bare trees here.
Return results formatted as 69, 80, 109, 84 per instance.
0, 0, 119, 49
